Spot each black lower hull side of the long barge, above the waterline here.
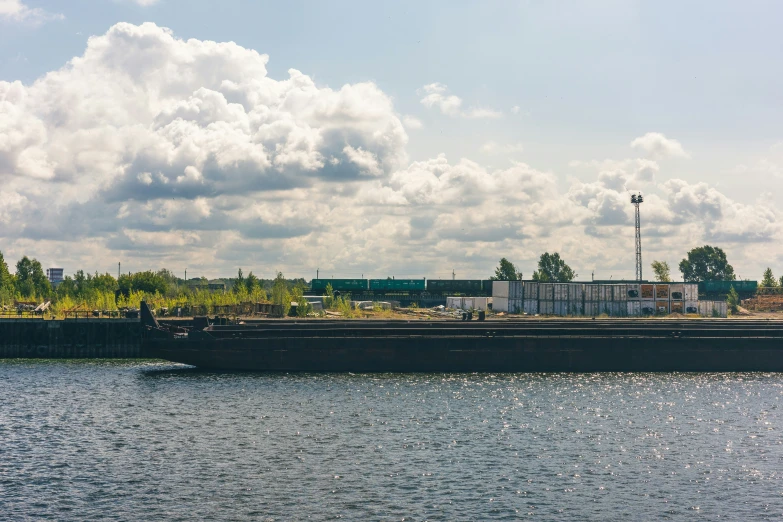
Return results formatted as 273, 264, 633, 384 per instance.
147, 336, 783, 372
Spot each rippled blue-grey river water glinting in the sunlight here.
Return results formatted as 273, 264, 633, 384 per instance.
0, 360, 783, 521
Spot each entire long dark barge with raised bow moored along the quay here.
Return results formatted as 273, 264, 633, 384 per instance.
142, 300, 783, 372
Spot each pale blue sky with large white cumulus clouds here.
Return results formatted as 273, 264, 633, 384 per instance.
0, 0, 783, 280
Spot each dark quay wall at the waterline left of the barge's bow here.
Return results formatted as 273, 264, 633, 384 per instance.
0, 319, 141, 359
